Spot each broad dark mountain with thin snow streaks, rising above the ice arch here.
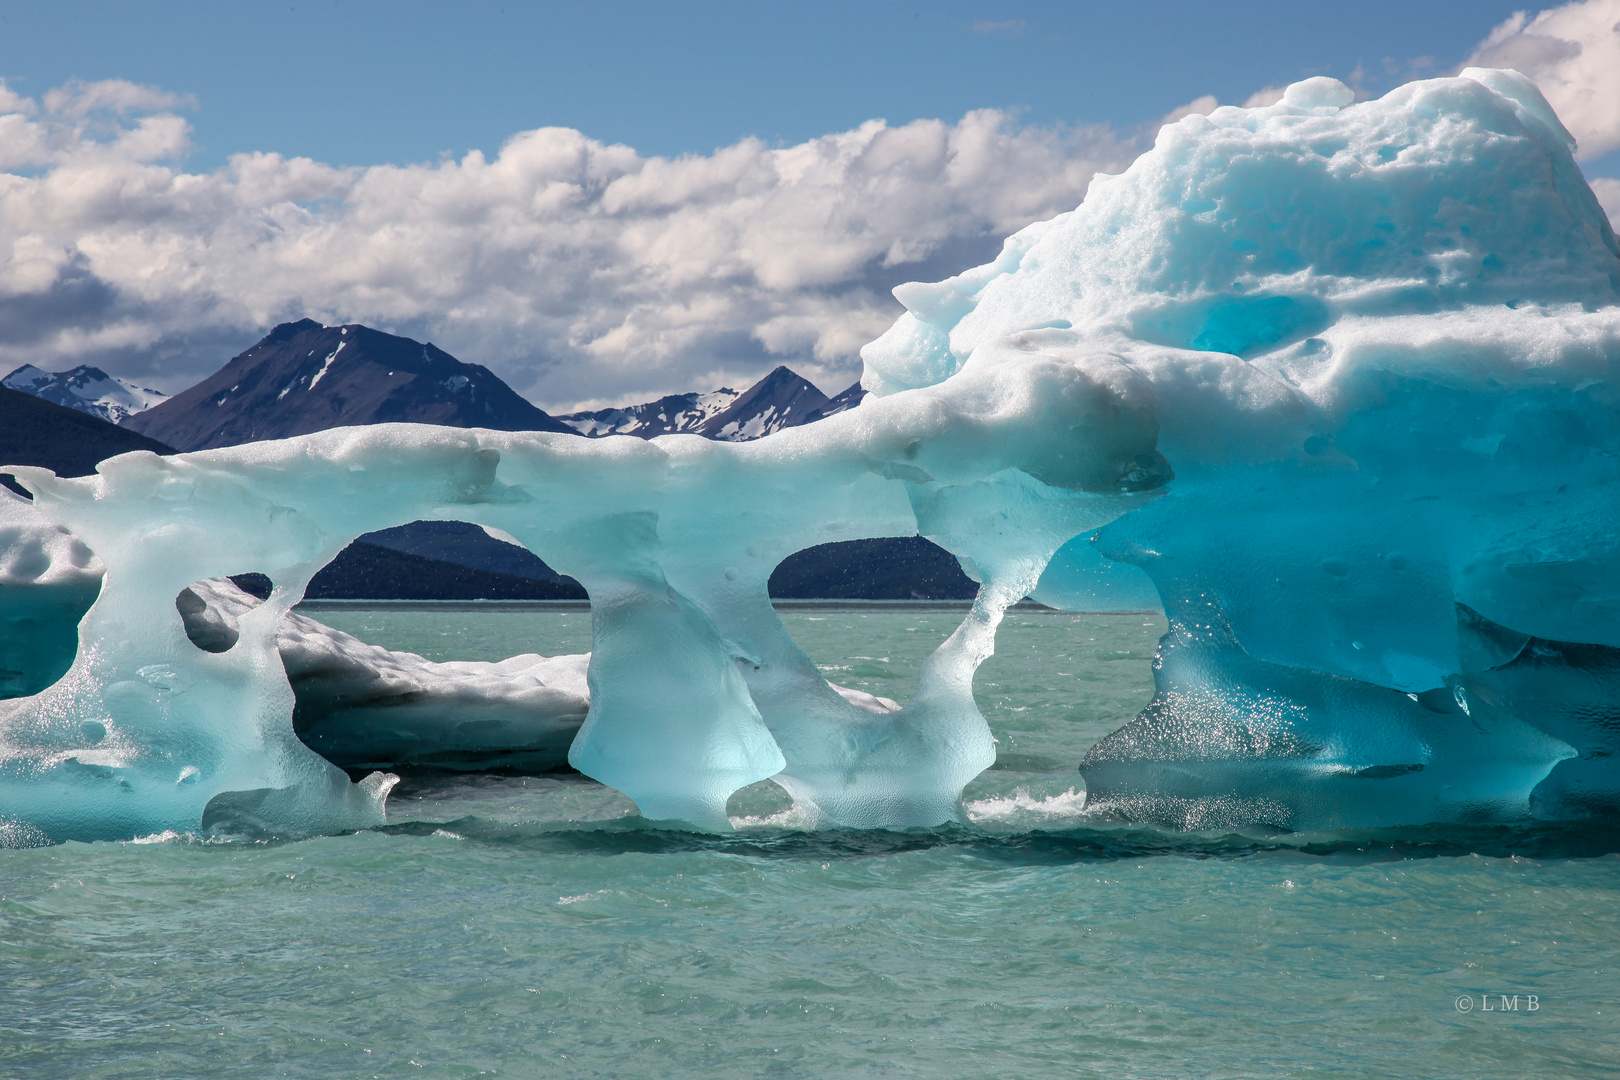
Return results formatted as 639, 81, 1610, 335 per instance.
123, 319, 575, 450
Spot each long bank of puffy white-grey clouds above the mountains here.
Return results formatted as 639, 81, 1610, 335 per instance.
0, 81, 1139, 408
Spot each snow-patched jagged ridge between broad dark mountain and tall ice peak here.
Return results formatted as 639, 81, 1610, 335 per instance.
557, 368, 865, 442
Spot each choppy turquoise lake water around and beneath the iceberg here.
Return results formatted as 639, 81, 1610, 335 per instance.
0, 607, 1620, 1080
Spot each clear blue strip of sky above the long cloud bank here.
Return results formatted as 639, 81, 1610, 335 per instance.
0, 0, 1555, 168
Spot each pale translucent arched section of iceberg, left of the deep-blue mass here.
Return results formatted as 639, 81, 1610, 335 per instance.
0, 361, 1170, 837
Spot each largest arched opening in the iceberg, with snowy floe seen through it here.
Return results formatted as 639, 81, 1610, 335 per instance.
279, 521, 591, 776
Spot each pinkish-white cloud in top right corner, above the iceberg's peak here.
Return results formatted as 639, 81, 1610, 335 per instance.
1463, 0, 1620, 159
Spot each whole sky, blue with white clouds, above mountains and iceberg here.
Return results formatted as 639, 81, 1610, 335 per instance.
0, 0, 1620, 411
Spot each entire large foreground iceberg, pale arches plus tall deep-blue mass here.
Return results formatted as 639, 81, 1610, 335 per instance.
0, 70, 1620, 839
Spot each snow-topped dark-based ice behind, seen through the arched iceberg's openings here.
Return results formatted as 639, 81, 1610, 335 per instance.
0, 544, 899, 772
